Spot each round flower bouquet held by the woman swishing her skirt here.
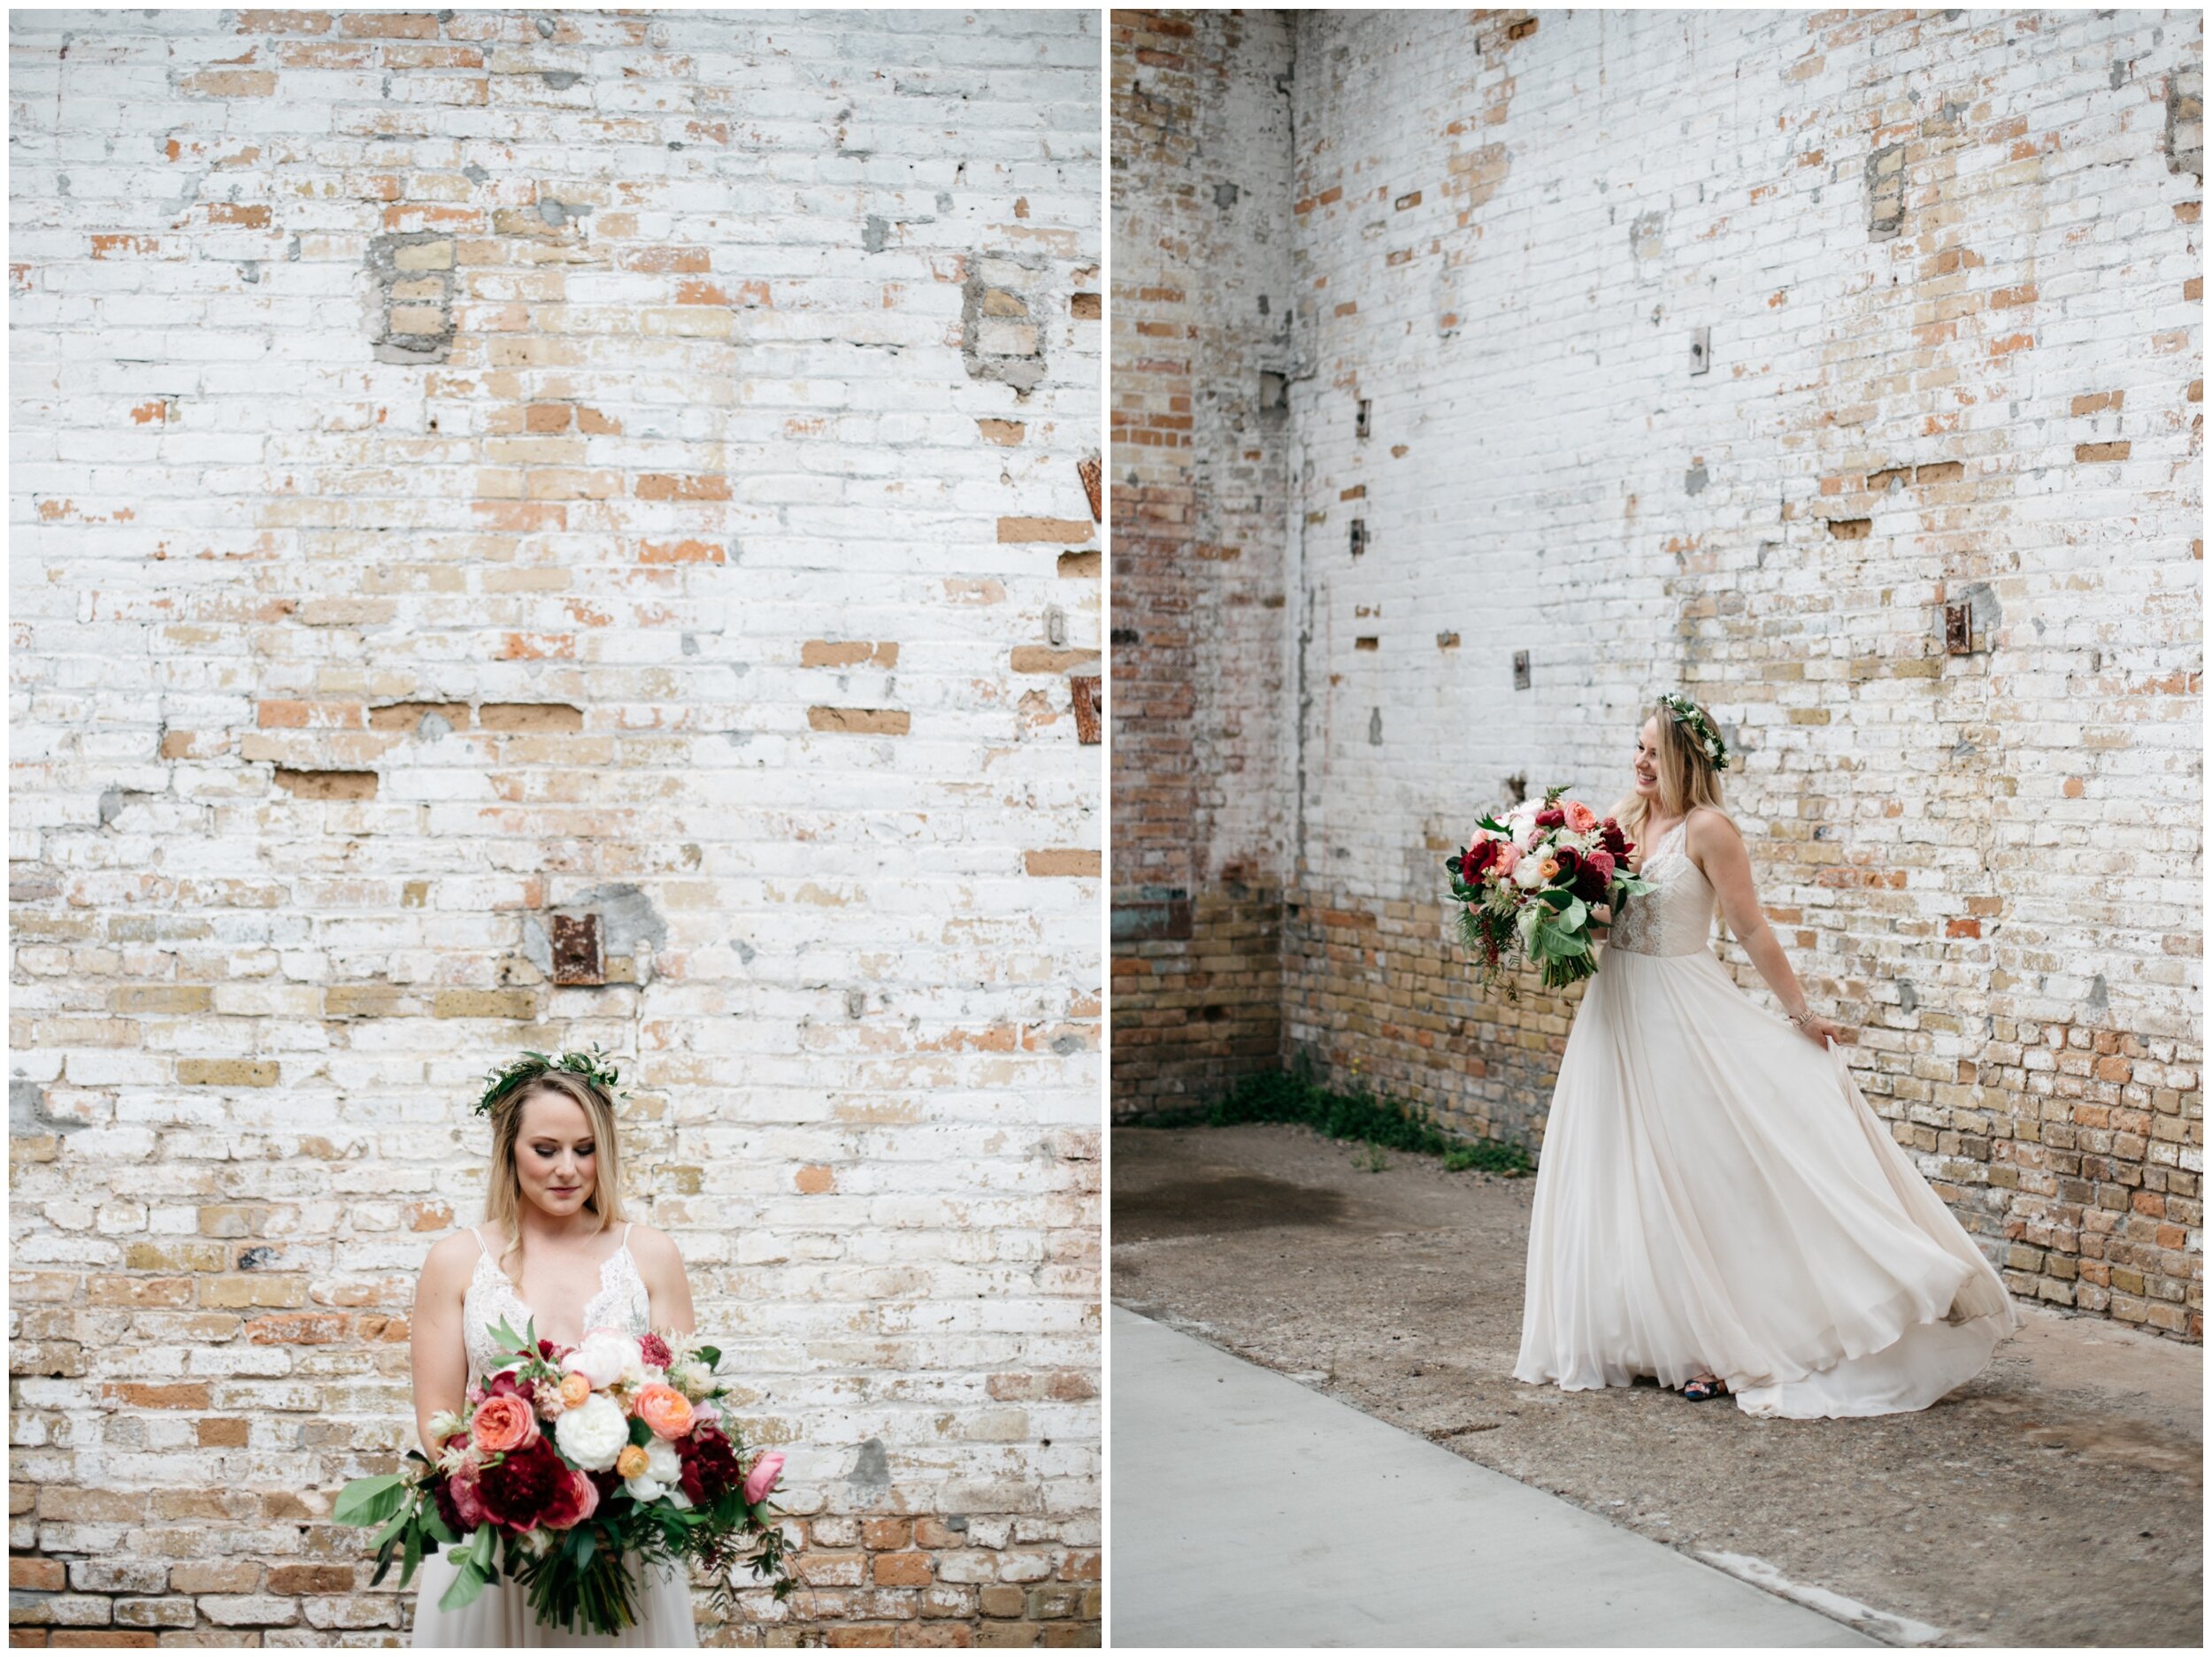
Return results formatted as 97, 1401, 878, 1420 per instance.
1445, 783, 1650, 1000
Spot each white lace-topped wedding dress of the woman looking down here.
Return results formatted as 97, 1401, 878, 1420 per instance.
411, 1225, 699, 1650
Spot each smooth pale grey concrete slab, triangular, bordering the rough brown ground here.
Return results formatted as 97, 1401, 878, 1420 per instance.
1109, 1308, 1878, 1648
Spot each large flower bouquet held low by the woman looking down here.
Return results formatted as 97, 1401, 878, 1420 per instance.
332, 1321, 792, 1635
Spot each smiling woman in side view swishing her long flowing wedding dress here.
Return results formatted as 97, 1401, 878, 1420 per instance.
1513, 693, 2020, 1418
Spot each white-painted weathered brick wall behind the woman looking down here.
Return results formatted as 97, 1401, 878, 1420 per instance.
9, 12, 1104, 1644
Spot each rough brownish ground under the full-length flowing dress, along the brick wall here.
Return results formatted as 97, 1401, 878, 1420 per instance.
1109, 1124, 2203, 1648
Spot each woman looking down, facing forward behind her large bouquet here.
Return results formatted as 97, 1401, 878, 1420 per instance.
414, 1053, 699, 1648
